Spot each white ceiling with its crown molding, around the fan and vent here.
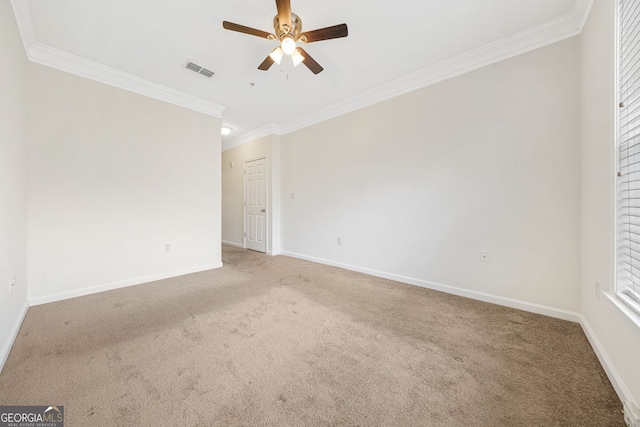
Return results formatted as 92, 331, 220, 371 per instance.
12, 0, 592, 146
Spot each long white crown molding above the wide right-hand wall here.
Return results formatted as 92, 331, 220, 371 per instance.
280, 0, 593, 134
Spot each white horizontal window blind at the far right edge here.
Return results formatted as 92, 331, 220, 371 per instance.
616, 0, 640, 314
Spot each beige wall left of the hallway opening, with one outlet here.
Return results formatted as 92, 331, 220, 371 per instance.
28, 64, 221, 303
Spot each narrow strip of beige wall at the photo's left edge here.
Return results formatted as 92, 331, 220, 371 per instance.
0, 1, 28, 369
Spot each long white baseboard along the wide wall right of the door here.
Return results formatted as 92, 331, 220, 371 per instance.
282, 251, 582, 323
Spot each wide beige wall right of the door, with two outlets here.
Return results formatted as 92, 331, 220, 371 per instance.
282, 38, 580, 318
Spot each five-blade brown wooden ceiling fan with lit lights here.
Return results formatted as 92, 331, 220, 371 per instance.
222, 0, 349, 74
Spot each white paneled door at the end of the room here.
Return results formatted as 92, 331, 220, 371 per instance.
244, 159, 267, 252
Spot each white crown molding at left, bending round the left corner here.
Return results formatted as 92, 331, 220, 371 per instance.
11, 0, 224, 118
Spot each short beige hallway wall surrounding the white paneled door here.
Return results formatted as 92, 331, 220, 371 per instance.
222, 135, 280, 254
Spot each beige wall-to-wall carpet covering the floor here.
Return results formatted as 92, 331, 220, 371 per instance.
0, 246, 624, 427
